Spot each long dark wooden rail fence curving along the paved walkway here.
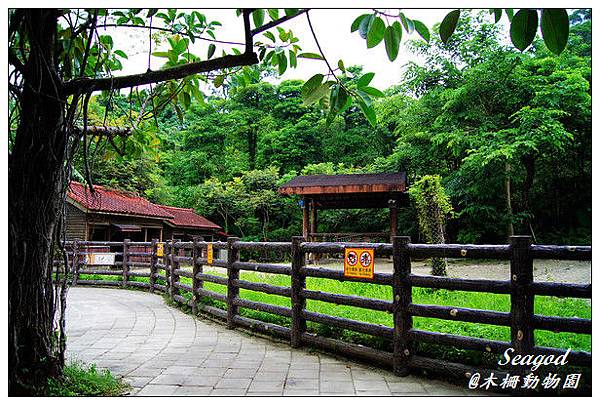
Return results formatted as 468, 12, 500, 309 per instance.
57, 236, 592, 378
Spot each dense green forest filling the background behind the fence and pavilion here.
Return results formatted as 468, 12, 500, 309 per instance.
74, 10, 592, 244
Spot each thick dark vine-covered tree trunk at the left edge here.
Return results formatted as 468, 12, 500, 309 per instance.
8, 9, 67, 395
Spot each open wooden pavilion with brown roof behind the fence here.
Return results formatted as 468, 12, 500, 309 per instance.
279, 172, 407, 240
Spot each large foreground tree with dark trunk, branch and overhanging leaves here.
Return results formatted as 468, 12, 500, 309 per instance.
8, 9, 568, 395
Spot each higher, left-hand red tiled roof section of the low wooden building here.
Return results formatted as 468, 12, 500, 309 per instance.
67, 181, 173, 219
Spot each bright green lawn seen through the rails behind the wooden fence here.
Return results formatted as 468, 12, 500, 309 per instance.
181, 272, 591, 351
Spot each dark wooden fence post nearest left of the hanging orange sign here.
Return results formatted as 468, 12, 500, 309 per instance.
290, 236, 306, 348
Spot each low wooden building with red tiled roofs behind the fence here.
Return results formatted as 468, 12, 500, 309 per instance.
65, 181, 223, 242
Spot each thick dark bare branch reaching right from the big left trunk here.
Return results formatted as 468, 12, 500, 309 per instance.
63, 52, 258, 95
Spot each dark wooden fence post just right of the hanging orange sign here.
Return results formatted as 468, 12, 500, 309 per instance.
392, 236, 412, 376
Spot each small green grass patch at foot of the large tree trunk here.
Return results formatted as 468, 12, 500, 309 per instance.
48, 363, 129, 397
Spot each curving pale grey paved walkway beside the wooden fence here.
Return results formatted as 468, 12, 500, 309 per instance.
67, 287, 470, 396
